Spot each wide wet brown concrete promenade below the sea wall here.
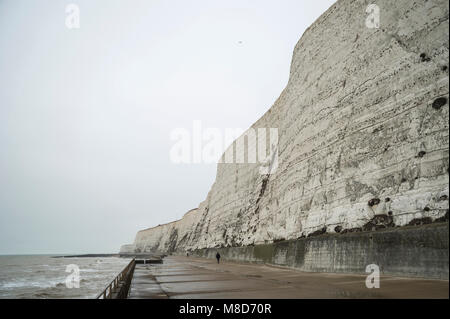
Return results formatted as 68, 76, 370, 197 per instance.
129, 256, 449, 299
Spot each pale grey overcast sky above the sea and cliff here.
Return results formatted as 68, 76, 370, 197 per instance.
0, 0, 334, 254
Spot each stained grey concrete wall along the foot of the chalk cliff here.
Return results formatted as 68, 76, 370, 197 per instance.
190, 223, 449, 280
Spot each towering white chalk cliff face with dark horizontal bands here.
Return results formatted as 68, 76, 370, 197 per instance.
123, 0, 449, 252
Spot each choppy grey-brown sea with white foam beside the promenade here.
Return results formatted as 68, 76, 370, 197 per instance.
0, 255, 130, 299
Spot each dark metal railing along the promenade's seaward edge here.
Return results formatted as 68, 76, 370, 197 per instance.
96, 258, 136, 299
